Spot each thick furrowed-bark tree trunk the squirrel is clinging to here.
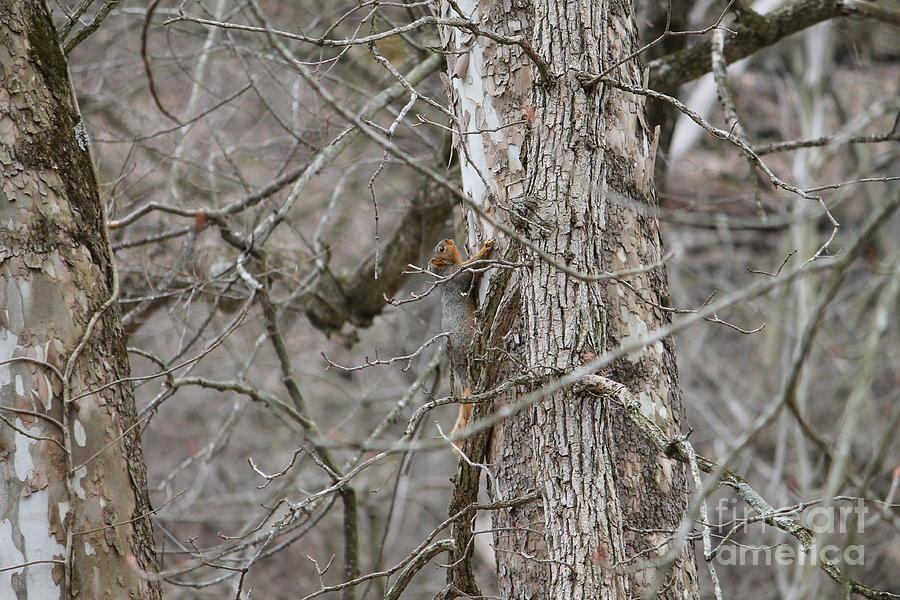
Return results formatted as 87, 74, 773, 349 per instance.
441, 0, 698, 600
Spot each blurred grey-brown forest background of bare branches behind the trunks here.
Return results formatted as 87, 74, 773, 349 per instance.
44, 0, 900, 599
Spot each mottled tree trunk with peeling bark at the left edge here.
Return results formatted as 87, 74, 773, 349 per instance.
0, 0, 160, 600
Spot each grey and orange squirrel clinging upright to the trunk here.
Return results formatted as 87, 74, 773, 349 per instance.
428, 239, 494, 446
